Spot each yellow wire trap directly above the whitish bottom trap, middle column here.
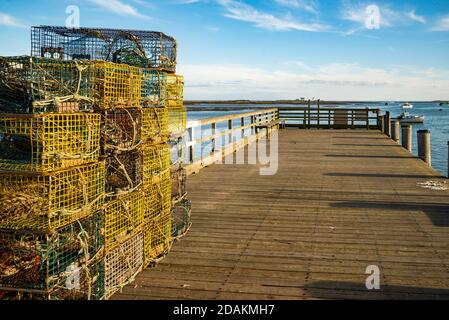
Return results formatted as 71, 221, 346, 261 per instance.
104, 191, 147, 251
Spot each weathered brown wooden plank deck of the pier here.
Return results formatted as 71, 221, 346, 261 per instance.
113, 129, 449, 299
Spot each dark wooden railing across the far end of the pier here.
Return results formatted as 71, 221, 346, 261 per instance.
279, 106, 381, 130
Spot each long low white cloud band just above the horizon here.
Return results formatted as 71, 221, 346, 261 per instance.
179, 62, 449, 100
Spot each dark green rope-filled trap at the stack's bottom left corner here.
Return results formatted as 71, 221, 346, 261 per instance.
0, 213, 104, 293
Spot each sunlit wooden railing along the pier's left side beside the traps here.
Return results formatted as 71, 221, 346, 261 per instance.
186, 108, 279, 174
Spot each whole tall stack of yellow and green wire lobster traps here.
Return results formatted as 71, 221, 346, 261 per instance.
0, 26, 190, 299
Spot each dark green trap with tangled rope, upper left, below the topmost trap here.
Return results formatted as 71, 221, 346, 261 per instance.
0, 56, 94, 113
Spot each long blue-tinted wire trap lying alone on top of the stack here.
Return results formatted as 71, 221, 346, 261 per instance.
31, 26, 177, 72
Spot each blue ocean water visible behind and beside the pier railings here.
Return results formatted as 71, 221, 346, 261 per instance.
188, 102, 449, 176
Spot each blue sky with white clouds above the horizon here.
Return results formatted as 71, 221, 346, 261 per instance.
0, 0, 449, 100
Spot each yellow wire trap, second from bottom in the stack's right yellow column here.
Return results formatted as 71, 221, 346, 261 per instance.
144, 170, 171, 220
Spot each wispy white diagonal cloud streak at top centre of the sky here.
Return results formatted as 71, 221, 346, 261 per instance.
217, 0, 327, 32
